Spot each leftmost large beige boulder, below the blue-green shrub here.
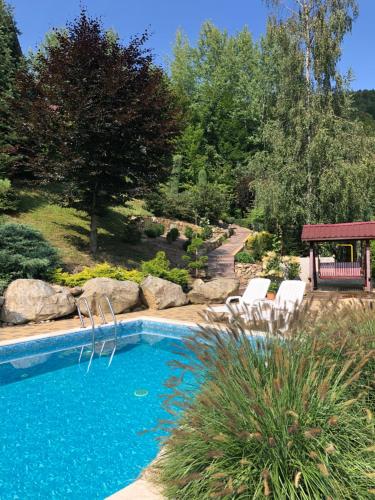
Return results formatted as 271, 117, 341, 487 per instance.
1, 279, 76, 324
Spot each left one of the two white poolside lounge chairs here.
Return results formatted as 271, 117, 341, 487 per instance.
208, 278, 271, 316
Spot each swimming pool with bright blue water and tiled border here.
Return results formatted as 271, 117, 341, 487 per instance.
0, 320, 198, 500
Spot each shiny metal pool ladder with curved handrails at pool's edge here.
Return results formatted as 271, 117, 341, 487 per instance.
77, 295, 117, 373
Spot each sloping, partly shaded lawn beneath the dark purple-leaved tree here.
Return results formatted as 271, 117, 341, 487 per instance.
6, 190, 187, 271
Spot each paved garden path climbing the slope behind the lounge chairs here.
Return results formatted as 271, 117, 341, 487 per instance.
208, 226, 251, 278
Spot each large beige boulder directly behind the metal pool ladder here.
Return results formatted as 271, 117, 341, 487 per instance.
78, 278, 139, 316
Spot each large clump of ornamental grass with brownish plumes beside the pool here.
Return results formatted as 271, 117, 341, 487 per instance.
155, 302, 375, 500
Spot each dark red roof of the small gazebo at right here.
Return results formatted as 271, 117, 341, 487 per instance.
301, 221, 375, 241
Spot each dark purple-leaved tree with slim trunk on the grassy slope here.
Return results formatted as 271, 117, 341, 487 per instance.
13, 11, 180, 254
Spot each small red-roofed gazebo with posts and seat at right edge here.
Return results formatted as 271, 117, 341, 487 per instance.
302, 221, 375, 292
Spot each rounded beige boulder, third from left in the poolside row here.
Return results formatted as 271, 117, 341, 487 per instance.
141, 276, 188, 309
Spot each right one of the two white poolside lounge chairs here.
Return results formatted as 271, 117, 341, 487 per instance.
241, 280, 306, 331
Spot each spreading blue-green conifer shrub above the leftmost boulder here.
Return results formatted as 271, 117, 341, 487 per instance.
0, 224, 59, 289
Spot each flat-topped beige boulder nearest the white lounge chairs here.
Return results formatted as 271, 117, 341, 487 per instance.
188, 278, 240, 304
